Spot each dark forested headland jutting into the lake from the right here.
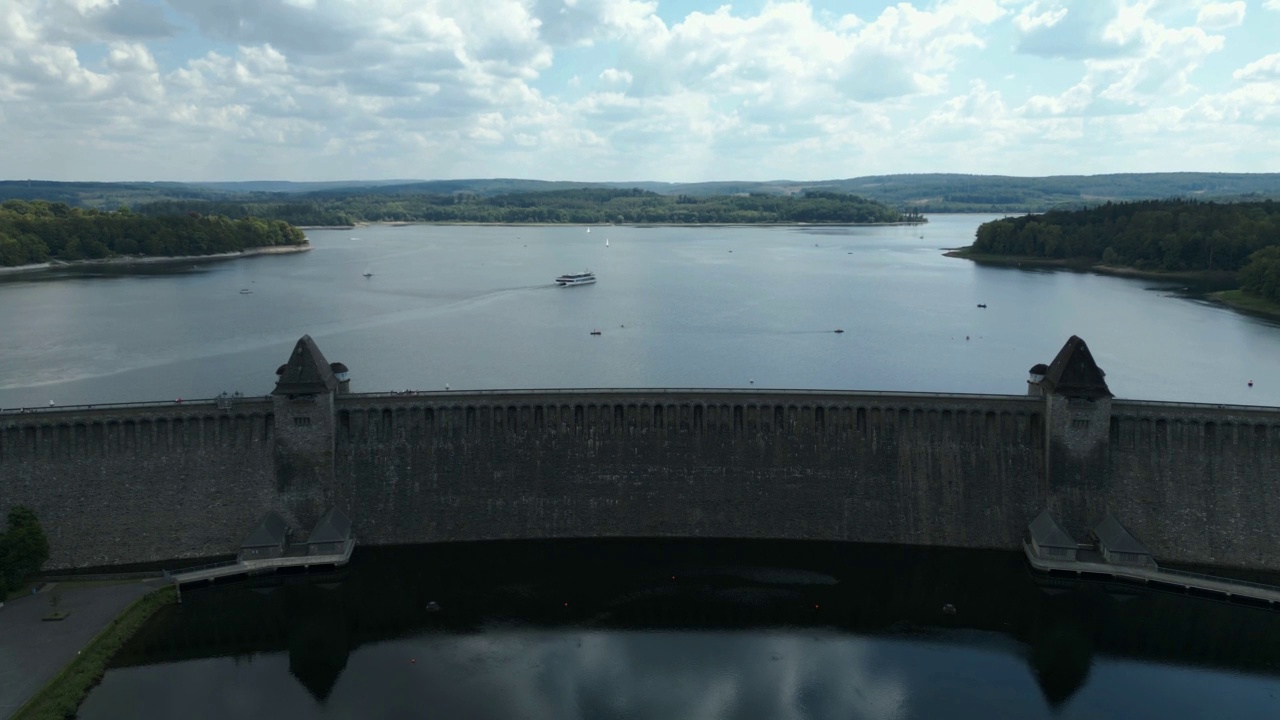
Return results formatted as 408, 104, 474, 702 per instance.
969, 200, 1280, 301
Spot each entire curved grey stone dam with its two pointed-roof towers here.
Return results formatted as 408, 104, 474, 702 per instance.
0, 337, 1280, 571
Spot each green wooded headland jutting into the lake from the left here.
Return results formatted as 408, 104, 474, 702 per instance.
0, 200, 307, 266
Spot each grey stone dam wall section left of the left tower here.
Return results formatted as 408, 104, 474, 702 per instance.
0, 401, 279, 569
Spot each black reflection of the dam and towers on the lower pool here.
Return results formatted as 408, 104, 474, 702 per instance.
104, 541, 1280, 707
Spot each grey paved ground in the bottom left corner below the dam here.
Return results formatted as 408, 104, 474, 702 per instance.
0, 579, 164, 717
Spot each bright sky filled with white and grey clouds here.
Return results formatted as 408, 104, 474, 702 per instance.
0, 0, 1280, 182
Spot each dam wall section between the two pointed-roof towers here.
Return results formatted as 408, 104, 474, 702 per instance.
337, 392, 1043, 547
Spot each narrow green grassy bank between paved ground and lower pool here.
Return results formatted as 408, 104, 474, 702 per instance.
13, 585, 178, 720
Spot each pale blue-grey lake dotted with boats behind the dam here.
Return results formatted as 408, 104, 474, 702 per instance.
0, 215, 1280, 407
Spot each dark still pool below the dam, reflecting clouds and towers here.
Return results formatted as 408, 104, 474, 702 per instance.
81, 541, 1280, 720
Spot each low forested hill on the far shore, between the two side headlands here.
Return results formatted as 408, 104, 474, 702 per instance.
136, 187, 923, 225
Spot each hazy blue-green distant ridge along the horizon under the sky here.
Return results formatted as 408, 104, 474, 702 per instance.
0, 173, 1280, 213
